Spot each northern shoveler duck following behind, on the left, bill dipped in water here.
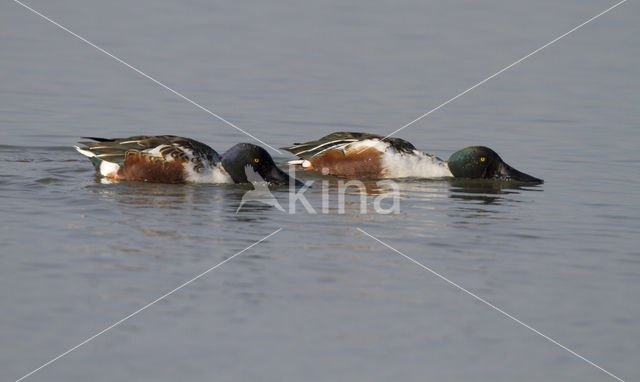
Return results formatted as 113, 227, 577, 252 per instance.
74, 135, 300, 185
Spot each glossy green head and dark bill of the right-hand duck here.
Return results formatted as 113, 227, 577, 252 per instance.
447, 146, 543, 183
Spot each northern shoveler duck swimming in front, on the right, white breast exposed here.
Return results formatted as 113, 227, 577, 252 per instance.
282, 132, 542, 183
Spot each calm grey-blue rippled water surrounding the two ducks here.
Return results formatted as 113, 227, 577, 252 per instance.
0, 0, 640, 382
